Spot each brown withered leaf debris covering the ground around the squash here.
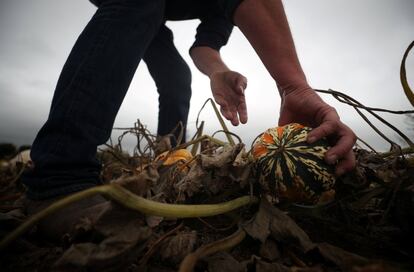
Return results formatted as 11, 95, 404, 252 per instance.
0, 127, 414, 271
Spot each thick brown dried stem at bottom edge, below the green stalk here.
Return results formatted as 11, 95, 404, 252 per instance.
179, 228, 246, 272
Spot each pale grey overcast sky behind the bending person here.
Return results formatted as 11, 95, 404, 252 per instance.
0, 0, 414, 153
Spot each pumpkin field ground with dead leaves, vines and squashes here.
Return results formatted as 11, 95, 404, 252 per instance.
0, 43, 414, 272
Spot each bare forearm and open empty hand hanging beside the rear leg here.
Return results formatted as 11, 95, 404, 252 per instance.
190, 46, 247, 126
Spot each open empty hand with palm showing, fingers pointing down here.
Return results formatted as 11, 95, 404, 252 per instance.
210, 71, 247, 126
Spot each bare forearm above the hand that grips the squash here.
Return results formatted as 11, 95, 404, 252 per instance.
234, 0, 309, 92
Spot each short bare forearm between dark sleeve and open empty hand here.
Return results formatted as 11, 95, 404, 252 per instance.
190, 46, 230, 78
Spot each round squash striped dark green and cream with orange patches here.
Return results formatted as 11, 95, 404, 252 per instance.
253, 123, 335, 204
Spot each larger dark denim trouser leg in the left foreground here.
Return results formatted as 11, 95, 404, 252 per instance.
22, 0, 165, 199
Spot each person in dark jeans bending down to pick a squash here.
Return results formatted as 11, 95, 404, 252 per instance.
22, 0, 356, 236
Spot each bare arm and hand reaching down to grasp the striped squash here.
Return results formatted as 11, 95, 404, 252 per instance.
233, 0, 356, 175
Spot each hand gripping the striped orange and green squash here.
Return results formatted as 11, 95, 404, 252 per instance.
279, 88, 356, 176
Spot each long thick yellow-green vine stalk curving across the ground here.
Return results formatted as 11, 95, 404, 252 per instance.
0, 184, 258, 251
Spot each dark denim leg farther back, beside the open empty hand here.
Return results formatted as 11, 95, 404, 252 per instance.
143, 25, 191, 144
